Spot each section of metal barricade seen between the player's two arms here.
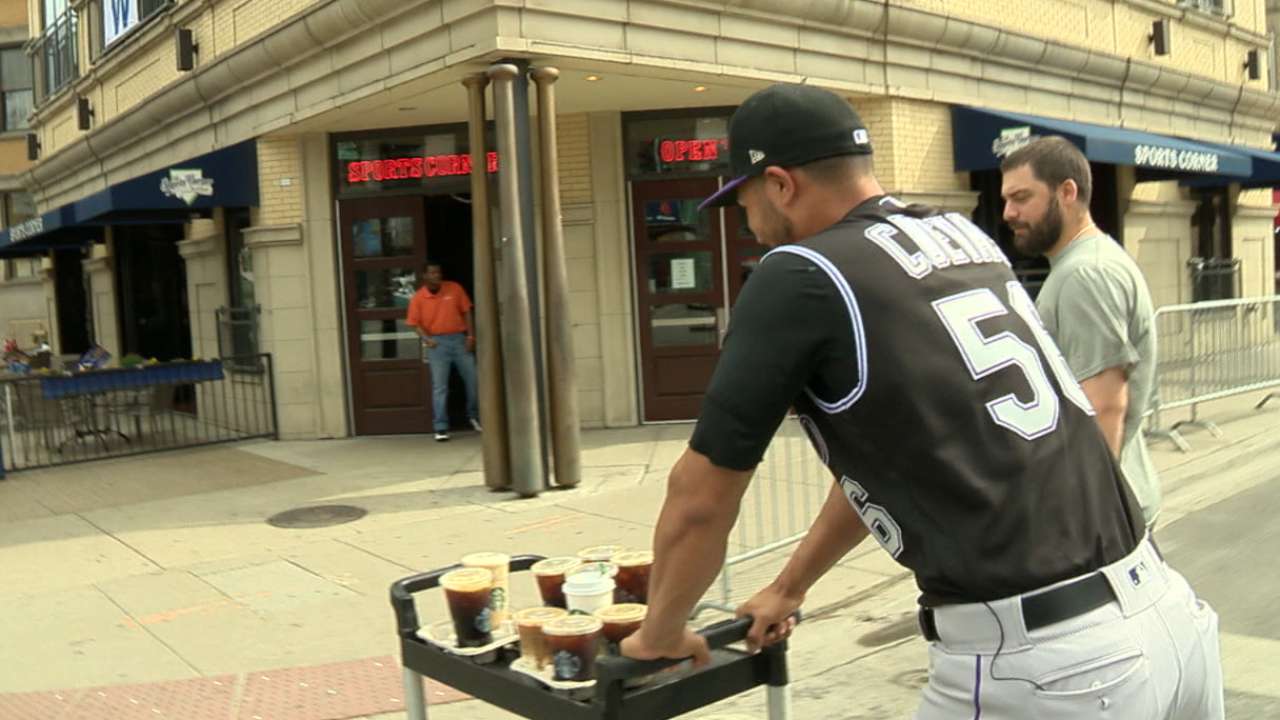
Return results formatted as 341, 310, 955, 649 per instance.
699, 416, 832, 611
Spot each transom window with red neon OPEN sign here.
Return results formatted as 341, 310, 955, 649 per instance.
623, 110, 728, 177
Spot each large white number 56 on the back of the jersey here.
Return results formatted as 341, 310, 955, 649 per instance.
933, 282, 1093, 439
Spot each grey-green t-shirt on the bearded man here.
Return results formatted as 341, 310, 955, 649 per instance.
1036, 234, 1161, 527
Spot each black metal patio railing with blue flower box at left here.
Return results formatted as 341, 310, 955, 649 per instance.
0, 355, 278, 478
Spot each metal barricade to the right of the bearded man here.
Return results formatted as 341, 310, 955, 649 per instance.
1147, 296, 1280, 451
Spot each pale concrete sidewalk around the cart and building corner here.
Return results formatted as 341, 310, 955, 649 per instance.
0, 398, 1280, 720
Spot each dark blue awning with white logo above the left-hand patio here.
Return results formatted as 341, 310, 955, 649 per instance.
0, 140, 259, 256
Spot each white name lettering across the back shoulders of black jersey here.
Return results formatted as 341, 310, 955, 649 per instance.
865, 213, 1009, 279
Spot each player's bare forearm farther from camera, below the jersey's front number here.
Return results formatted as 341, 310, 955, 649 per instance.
773, 483, 868, 597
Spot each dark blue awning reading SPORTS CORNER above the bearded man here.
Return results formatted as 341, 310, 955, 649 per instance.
951, 105, 1253, 182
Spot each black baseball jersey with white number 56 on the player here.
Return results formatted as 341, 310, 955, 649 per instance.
690, 196, 1143, 605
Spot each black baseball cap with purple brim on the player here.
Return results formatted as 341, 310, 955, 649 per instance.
698, 85, 872, 210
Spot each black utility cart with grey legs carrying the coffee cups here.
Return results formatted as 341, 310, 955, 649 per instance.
390, 555, 790, 720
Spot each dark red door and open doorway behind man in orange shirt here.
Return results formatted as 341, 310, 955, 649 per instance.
339, 195, 472, 436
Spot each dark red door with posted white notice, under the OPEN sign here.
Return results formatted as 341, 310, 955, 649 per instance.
631, 178, 765, 421
